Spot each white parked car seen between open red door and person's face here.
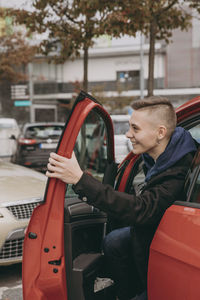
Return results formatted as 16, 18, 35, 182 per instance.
111, 115, 132, 163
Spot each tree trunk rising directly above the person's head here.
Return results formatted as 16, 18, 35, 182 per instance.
147, 21, 156, 97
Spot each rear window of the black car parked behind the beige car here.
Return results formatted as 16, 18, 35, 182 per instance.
25, 126, 63, 139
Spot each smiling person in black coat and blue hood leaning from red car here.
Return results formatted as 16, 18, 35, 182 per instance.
46, 97, 196, 300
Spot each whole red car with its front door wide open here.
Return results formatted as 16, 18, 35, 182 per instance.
23, 92, 200, 300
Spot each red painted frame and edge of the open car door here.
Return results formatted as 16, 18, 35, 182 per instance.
23, 93, 114, 300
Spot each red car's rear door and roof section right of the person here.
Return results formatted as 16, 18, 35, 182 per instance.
148, 97, 200, 300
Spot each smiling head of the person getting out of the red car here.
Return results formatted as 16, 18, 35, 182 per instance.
126, 97, 176, 160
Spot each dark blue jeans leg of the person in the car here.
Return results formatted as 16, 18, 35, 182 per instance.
103, 227, 145, 300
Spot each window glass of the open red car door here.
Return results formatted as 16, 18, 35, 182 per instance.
66, 110, 107, 197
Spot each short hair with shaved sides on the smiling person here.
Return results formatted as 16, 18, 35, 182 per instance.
132, 96, 177, 136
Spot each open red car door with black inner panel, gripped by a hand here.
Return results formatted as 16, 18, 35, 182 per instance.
22, 92, 117, 300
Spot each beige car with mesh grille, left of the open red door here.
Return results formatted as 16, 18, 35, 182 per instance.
0, 160, 46, 265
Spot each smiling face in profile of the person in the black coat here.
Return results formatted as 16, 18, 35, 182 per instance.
126, 109, 159, 158
